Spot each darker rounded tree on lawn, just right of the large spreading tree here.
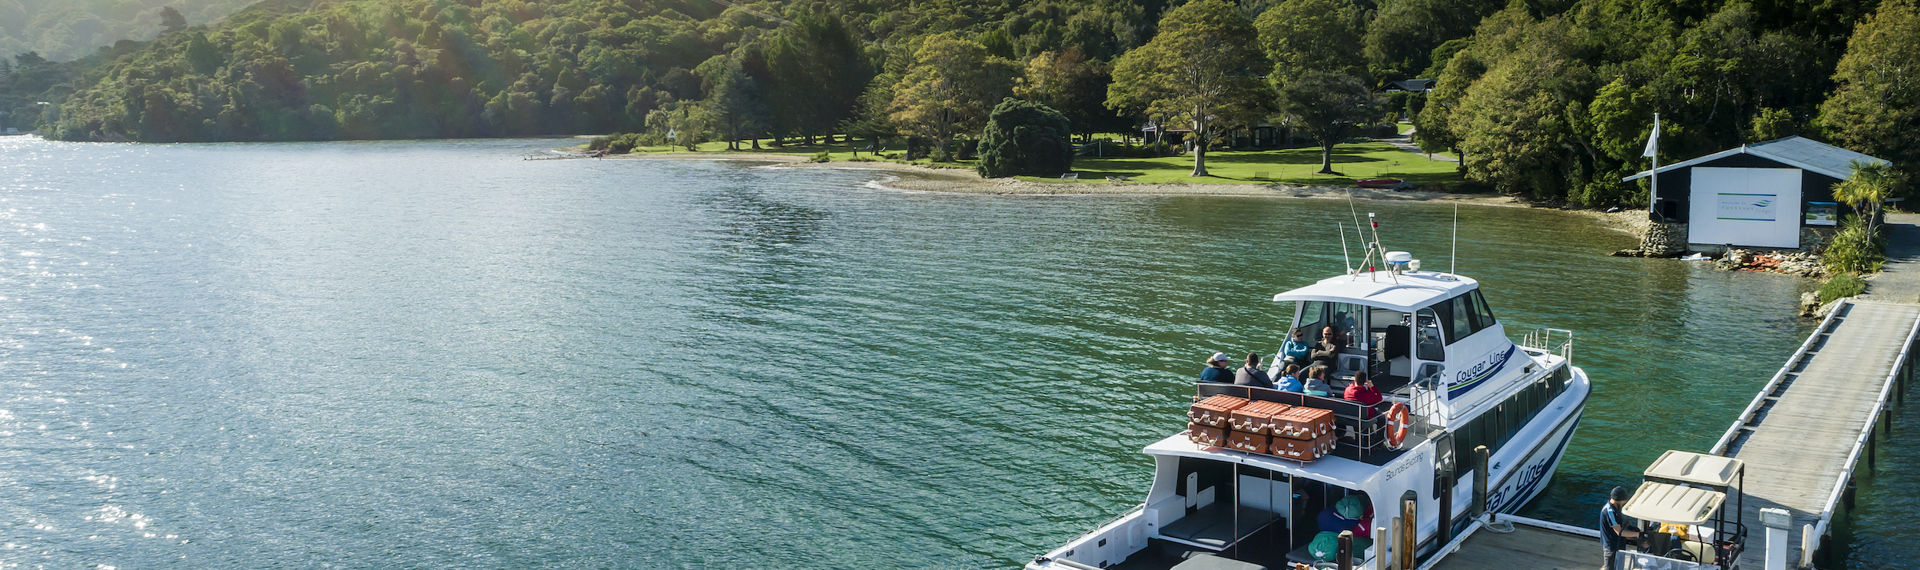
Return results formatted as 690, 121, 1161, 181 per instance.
1277, 69, 1380, 175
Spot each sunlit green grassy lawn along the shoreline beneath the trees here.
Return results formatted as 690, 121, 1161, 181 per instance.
591, 140, 1461, 186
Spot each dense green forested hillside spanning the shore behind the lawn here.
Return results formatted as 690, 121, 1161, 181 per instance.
0, 0, 1920, 203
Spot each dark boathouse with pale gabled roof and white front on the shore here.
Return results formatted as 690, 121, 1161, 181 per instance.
1626, 136, 1887, 251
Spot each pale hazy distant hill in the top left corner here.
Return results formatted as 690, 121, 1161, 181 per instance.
0, 0, 255, 61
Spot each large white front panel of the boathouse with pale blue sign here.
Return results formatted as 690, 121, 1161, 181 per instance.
1686, 167, 1801, 248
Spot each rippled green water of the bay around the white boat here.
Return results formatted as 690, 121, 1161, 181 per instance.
0, 138, 1889, 568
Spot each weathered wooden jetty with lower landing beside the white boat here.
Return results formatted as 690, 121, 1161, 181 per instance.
1421, 299, 1920, 570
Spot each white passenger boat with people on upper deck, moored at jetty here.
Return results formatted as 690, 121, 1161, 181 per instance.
1027, 246, 1592, 570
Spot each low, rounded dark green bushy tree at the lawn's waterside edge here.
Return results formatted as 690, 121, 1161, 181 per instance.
979, 98, 1073, 178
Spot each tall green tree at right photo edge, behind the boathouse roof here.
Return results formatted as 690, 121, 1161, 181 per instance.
1820, 0, 1920, 177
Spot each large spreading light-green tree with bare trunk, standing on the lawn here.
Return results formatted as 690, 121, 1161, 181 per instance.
1106, 0, 1269, 177
